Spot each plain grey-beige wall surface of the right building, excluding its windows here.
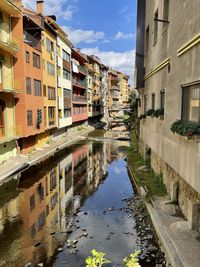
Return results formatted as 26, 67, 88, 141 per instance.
140, 0, 200, 225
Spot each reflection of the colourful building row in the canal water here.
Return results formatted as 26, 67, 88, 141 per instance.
0, 137, 128, 267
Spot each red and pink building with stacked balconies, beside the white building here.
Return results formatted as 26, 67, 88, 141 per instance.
72, 49, 88, 123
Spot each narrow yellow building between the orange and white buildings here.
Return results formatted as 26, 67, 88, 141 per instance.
42, 17, 58, 136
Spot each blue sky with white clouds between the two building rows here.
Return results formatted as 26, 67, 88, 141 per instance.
23, 0, 136, 84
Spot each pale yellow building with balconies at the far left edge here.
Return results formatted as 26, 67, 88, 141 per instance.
0, 0, 22, 163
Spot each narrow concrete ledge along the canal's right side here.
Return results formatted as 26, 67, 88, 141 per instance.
127, 161, 186, 267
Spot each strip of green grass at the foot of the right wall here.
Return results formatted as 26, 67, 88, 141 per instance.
128, 131, 166, 197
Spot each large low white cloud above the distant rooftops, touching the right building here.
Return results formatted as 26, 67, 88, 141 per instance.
81, 47, 135, 84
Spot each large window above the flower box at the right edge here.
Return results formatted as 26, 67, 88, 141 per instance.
182, 84, 200, 122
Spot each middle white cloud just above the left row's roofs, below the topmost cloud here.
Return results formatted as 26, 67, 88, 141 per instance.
62, 26, 105, 45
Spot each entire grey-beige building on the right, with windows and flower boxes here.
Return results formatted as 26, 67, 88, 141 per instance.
135, 0, 200, 229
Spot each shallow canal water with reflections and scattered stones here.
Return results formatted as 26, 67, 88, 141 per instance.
0, 132, 164, 267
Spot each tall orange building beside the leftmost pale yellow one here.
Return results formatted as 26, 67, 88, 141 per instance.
14, 5, 44, 152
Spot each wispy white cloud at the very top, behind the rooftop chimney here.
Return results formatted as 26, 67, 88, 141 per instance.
23, 0, 77, 20
